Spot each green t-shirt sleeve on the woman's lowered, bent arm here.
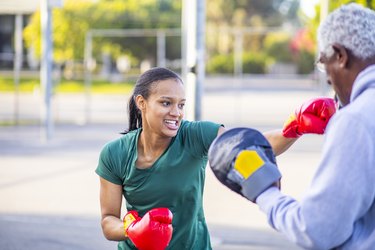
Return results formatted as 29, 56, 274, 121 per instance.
95, 143, 122, 185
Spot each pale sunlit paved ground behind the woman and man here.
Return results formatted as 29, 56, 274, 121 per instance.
0, 77, 330, 250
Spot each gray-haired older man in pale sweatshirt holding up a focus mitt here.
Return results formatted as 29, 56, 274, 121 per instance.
211, 4, 375, 249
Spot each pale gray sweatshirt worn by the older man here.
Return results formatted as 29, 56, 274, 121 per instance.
256, 65, 375, 250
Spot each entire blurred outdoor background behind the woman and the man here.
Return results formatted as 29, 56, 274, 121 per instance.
0, 0, 375, 250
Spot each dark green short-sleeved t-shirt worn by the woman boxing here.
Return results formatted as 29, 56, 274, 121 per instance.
96, 121, 220, 250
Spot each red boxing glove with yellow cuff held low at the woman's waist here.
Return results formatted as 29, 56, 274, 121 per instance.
124, 207, 173, 250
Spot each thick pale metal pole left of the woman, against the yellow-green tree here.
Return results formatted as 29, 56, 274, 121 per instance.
40, 0, 53, 141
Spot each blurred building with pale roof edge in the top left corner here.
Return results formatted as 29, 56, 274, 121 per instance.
0, 0, 40, 70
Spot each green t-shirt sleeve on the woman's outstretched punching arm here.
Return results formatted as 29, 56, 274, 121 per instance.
186, 121, 223, 157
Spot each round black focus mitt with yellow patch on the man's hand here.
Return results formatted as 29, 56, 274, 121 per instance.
208, 128, 281, 202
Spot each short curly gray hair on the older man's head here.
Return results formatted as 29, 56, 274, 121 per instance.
318, 3, 375, 60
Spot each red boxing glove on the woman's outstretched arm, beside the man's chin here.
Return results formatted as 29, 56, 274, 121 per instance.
283, 97, 336, 138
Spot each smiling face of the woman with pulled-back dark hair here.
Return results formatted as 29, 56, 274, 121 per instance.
138, 79, 186, 137
